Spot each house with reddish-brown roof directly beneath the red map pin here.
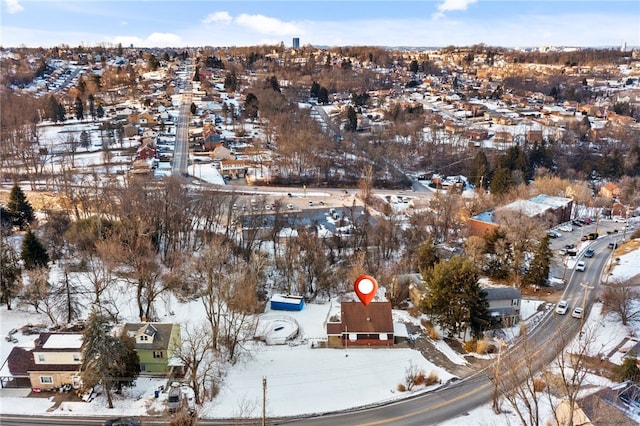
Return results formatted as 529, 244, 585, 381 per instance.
327, 302, 394, 348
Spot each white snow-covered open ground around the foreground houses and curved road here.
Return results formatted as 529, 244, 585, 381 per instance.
0, 246, 640, 426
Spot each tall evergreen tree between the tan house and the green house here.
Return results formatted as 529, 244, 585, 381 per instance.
81, 309, 140, 408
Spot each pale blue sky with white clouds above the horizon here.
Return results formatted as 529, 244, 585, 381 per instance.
0, 0, 640, 47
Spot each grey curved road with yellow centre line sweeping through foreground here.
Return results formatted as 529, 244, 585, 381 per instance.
0, 236, 613, 426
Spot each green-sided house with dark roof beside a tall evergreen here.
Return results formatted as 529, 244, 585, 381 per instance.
124, 322, 182, 375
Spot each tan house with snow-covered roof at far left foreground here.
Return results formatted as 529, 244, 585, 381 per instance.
7, 333, 82, 390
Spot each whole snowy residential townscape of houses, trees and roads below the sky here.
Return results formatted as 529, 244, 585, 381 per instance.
0, 4, 640, 425
